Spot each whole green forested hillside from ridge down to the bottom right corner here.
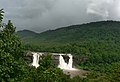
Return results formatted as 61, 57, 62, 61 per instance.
18, 21, 120, 82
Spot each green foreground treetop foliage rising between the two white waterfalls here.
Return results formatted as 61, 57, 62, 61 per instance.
22, 54, 70, 82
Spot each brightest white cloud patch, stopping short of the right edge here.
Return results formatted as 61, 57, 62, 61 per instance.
87, 0, 114, 18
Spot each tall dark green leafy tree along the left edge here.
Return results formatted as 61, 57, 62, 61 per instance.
0, 9, 25, 82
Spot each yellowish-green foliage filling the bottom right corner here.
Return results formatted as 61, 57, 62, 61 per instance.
87, 62, 120, 82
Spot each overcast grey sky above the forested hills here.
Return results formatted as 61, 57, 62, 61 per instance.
0, 0, 120, 32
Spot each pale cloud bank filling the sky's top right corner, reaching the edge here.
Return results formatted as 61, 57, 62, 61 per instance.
87, 0, 120, 20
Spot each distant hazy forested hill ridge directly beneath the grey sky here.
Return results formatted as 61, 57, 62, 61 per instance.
18, 21, 120, 45
